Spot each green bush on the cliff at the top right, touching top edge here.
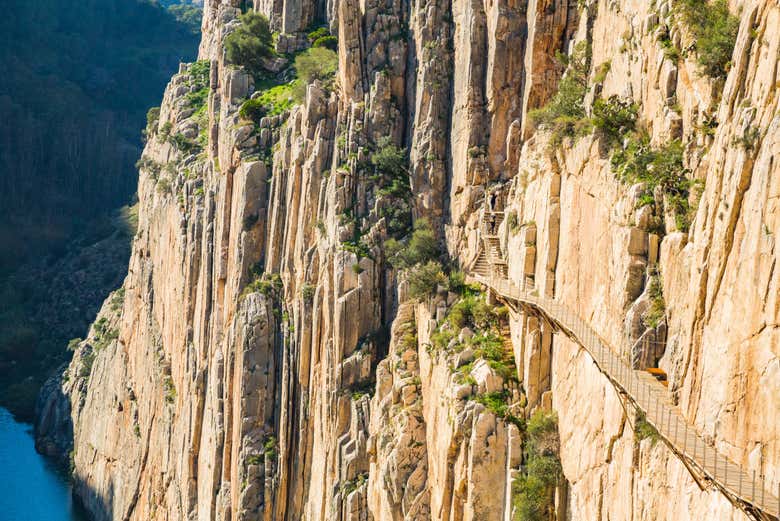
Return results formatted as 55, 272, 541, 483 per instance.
674, 0, 739, 78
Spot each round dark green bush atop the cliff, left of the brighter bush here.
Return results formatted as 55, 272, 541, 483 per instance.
225, 11, 275, 76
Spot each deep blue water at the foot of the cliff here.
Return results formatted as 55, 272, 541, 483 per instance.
0, 408, 88, 521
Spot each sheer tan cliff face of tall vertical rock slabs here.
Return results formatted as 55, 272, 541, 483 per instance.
38, 0, 780, 521
